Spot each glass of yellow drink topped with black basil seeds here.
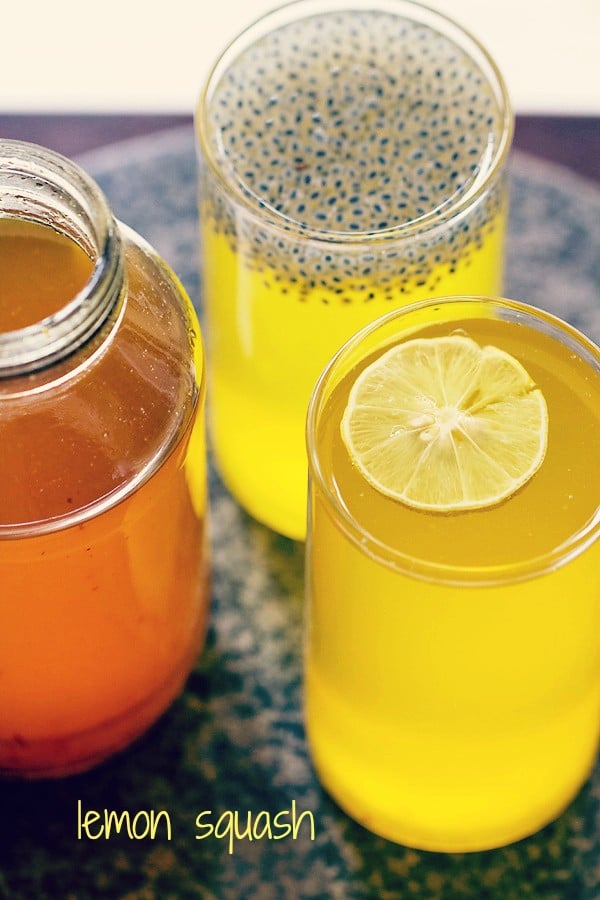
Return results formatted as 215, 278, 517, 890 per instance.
197, 0, 512, 538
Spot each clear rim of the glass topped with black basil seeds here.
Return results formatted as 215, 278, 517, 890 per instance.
194, 0, 514, 246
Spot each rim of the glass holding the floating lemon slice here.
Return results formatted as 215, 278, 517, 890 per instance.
305, 295, 600, 587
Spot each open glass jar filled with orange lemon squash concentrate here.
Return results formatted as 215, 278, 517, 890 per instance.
0, 140, 209, 778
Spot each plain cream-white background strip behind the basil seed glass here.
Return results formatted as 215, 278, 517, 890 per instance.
0, 0, 600, 115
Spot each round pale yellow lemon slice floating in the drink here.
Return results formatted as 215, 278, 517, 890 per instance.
341, 334, 548, 511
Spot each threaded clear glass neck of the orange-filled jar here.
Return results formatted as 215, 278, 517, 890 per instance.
0, 140, 123, 378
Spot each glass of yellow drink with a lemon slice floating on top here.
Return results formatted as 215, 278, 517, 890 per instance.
305, 298, 600, 851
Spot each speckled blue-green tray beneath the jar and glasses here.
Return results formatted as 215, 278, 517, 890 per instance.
0, 128, 600, 900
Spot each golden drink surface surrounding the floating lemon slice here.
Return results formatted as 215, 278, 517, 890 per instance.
319, 320, 600, 566
